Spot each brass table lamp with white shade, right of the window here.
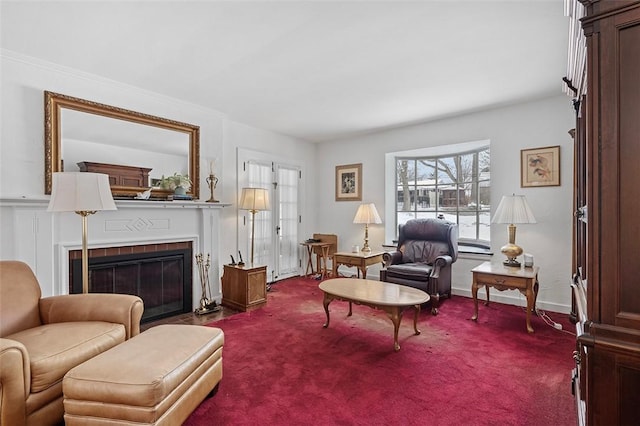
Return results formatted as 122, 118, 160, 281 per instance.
491, 194, 536, 268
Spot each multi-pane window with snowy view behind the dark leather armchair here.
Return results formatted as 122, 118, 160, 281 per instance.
395, 145, 491, 247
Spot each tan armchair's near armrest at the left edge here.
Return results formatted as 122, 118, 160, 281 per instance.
0, 338, 31, 425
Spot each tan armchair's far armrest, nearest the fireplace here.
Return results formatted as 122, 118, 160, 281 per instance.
40, 293, 144, 340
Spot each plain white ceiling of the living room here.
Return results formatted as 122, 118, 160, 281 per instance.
0, 0, 568, 141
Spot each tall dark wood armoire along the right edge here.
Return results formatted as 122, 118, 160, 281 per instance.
569, 0, 640, 425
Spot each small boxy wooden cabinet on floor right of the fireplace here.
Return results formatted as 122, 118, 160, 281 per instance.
222, 265, 267, 311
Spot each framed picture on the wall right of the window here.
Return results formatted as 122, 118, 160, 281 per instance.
520, 145, 560, 188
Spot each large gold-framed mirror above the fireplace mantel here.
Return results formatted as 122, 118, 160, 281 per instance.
44, 91, 200, 200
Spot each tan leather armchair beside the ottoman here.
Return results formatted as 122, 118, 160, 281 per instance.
0, 261, 144, 426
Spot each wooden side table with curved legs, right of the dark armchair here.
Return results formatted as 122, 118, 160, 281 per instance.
471, 262, 539, 333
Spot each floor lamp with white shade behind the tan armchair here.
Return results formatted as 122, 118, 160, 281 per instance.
47, 172, 116, 293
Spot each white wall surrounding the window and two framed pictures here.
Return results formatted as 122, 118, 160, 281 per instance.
316, 94, 574, 312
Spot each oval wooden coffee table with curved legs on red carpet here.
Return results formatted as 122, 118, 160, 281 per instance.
319, 278, 429, 352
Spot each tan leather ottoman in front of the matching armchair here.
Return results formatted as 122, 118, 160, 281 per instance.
62, 325, 224, 426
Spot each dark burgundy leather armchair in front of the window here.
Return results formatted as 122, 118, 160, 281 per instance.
380, 219, 458, 315
